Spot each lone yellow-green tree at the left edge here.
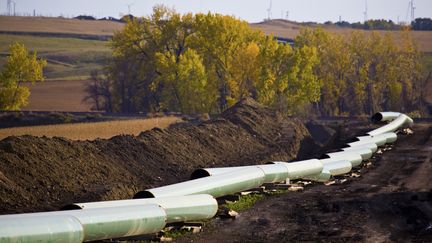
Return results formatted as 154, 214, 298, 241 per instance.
0, 43, 46, 110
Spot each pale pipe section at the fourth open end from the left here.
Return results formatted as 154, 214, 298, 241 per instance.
271, 159, 323, 180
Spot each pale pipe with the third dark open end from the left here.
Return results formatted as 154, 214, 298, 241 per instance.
191, 164, 288, 183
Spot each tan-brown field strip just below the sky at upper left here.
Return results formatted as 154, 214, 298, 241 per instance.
0, 16, 124, 35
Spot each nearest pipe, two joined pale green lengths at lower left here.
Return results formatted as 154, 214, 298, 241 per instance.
0, 204, 166, 242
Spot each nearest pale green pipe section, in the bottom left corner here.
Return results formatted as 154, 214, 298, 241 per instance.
0, 214, 84, 243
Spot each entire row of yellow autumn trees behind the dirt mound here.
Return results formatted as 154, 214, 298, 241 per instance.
87, 6, 421, 115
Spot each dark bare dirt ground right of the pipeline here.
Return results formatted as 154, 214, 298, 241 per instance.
179, 124, 432, 242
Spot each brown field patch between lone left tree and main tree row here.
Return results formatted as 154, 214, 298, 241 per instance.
22, 80, 92, 112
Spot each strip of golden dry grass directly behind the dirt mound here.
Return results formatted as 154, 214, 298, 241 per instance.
0, 117, 181, 140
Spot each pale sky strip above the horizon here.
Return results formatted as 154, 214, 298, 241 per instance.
0, 0, 432, 23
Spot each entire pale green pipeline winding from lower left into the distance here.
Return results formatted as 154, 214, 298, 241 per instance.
0, 112, 413, 242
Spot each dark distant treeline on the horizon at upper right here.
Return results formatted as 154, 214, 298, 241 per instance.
324, 18, 432, 30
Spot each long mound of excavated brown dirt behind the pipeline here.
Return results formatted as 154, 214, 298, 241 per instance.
0, 99, 328, 214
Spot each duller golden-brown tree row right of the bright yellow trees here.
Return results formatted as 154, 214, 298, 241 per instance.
296, 29, 422, 115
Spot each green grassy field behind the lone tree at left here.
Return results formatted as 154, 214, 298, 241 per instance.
0, 34, 111, 80
